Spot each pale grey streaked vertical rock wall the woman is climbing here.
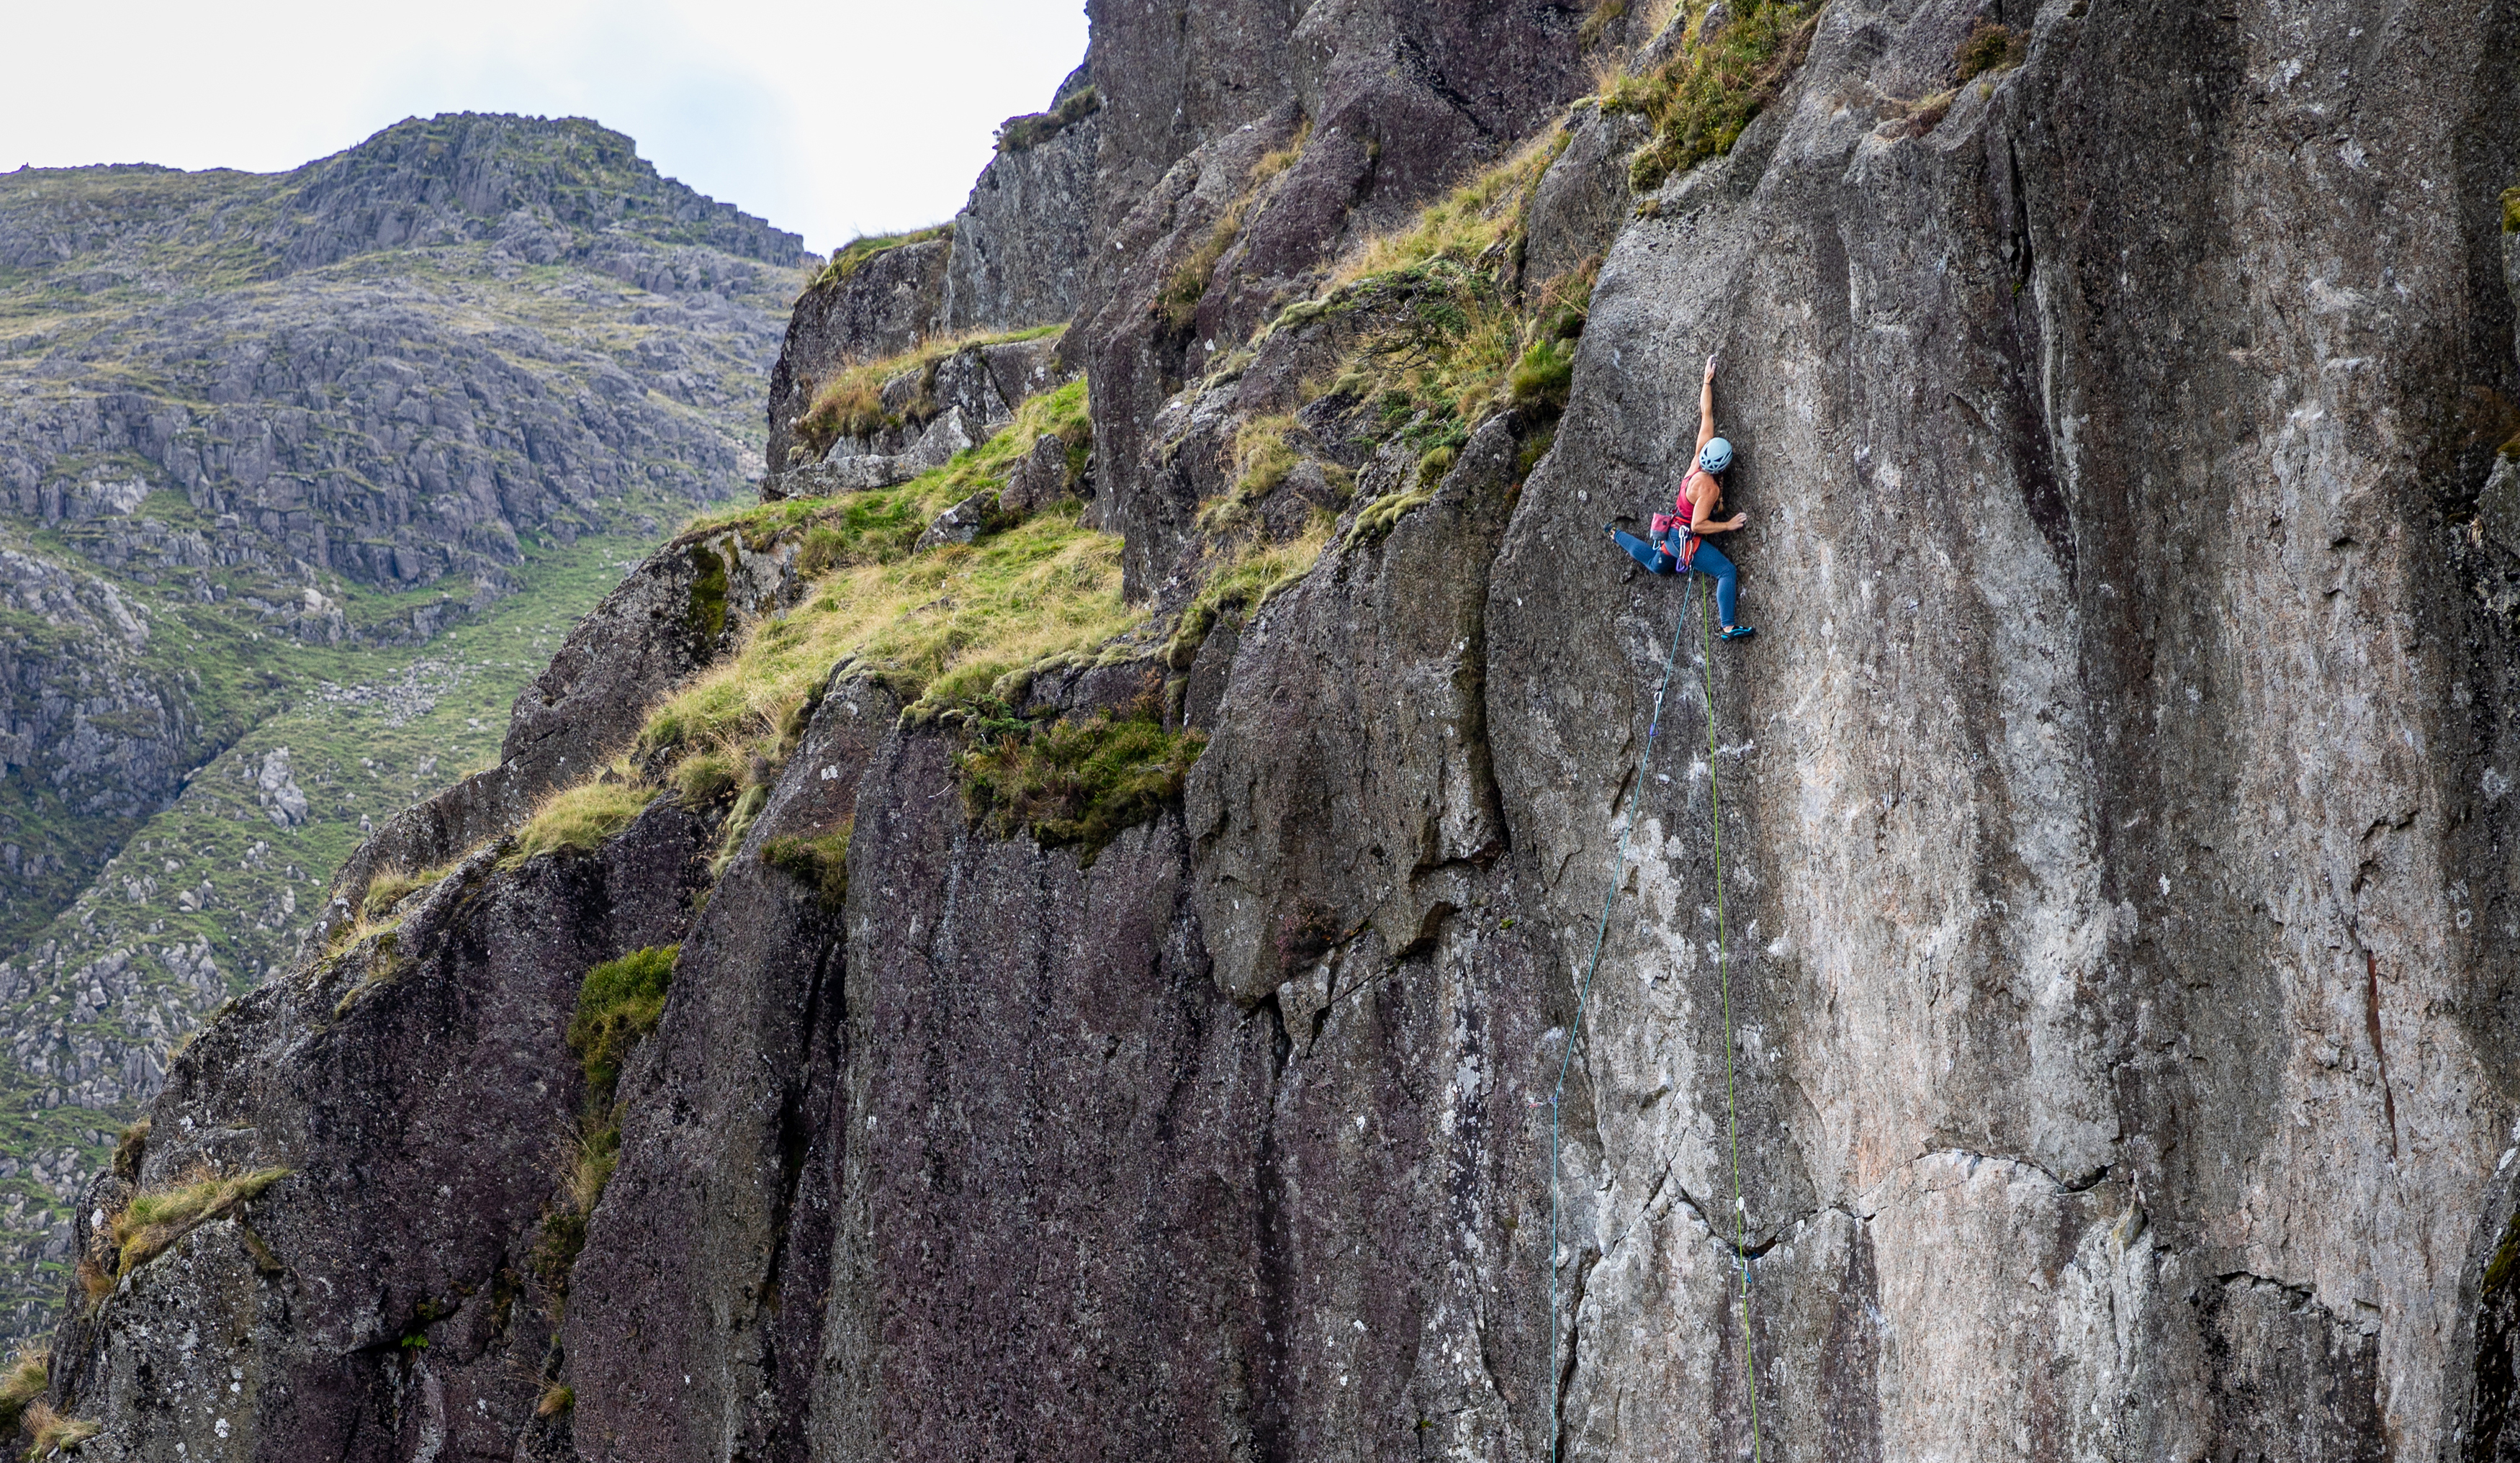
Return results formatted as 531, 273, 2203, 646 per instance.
1490, 5, 2515, 1458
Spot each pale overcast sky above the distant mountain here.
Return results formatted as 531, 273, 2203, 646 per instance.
0, 0, 1086, 254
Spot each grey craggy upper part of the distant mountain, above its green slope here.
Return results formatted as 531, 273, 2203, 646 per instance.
0, 113, 804, 950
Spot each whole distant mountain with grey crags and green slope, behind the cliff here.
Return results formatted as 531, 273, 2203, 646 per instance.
0, 116, 804, 1330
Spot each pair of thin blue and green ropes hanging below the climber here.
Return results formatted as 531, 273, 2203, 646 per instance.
1545, 574, 1764, 1463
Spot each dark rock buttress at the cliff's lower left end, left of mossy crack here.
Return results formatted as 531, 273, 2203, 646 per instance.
53, 803, 708, 1458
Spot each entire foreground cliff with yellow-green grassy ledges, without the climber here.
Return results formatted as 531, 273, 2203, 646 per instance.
19, 0, 2520, 1461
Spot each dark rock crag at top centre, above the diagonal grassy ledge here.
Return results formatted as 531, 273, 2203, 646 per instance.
1068, 0, 1583, 592
